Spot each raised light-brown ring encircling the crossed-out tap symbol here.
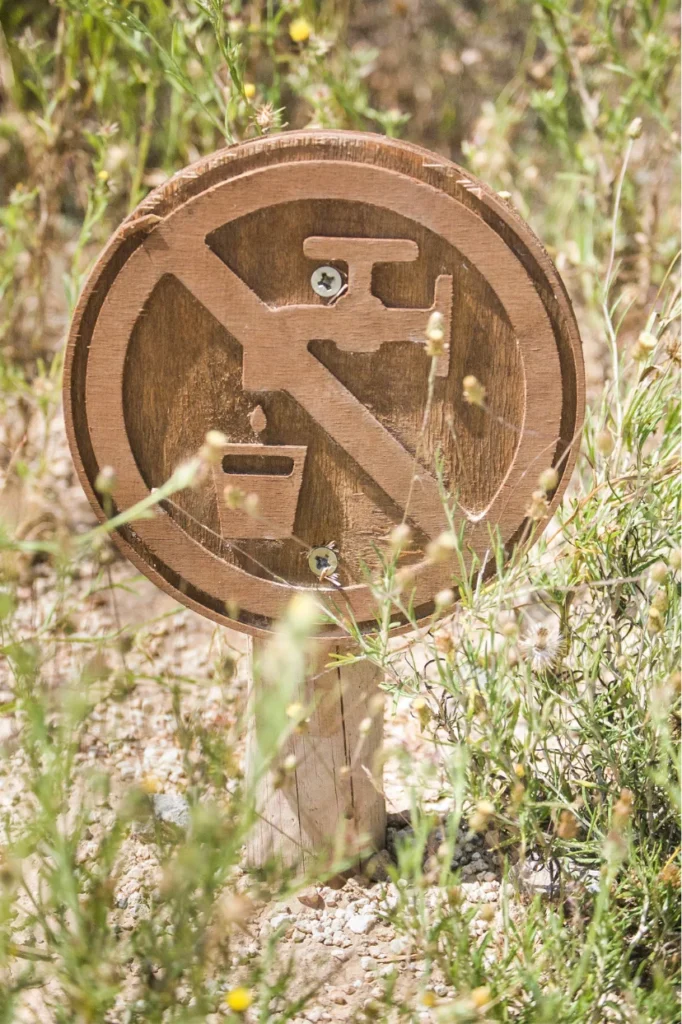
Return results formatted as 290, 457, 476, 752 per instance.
65, 133, 582, 634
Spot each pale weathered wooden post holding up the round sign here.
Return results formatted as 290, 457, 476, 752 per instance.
247, 640, 386, 869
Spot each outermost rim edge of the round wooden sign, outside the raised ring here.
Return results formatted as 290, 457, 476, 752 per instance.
63, 132, 584, 637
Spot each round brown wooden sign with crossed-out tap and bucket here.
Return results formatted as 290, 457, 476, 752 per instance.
65, 132, 584, 633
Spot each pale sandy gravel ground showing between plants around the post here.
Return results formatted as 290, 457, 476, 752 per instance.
0, 407, 548, 1022
